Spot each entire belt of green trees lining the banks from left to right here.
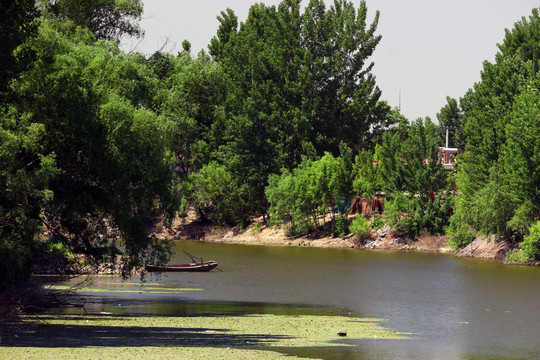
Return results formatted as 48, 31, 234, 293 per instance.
0, 0, 540, 291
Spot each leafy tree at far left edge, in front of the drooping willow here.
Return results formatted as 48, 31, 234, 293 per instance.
0, 106, 58, 293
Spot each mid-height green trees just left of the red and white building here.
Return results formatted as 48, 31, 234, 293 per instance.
353, 119, 454, 239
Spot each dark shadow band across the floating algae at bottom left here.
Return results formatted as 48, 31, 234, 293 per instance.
0, 315, 288, 348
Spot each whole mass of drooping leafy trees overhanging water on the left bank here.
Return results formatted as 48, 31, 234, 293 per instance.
0, 3, 170, 289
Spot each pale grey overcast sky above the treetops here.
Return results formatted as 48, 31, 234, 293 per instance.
123, 0, 540, 120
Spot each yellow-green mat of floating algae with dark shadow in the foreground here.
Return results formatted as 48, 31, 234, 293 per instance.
0, 314, 409, 360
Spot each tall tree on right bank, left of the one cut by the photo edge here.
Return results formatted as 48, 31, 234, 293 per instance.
451, 9, 540, 245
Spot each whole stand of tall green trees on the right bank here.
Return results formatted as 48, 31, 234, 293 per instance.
452, 8, 540, 243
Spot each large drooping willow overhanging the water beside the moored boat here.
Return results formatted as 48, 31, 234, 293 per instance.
8, 21, 175, 276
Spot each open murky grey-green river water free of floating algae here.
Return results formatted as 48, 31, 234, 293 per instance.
61, 242, 540, 359
